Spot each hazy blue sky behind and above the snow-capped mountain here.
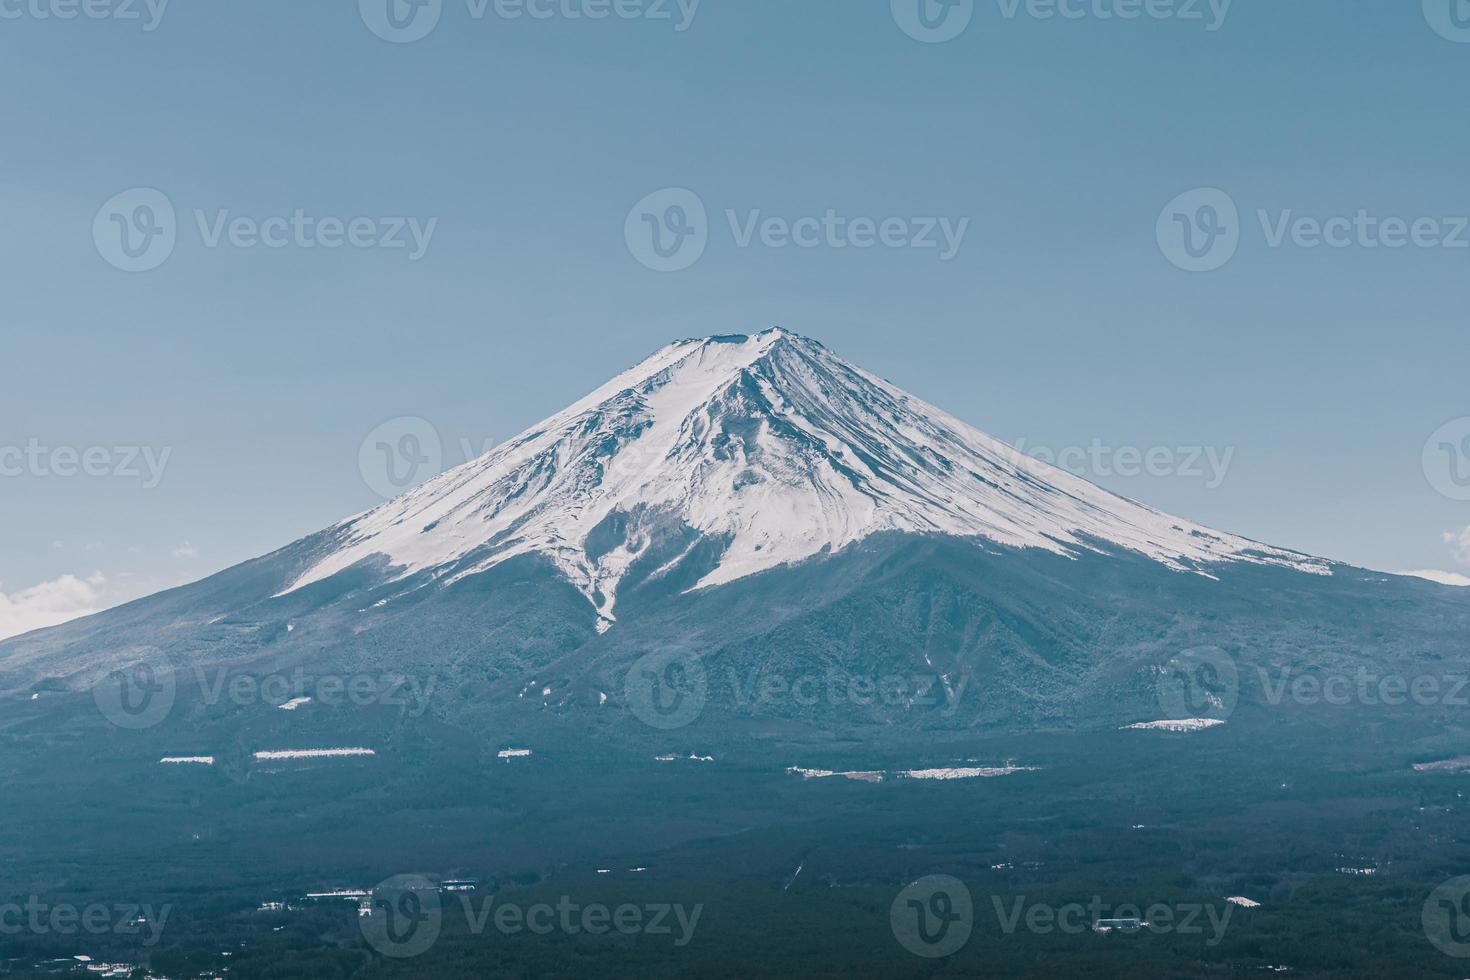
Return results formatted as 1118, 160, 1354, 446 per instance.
0, 0, 1470, 633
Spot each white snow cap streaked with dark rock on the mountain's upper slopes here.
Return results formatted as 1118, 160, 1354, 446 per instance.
287, 329, 1330, 621
